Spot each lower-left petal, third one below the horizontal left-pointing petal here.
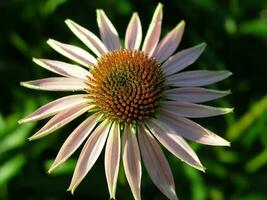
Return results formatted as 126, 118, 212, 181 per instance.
48, 115, 97, 173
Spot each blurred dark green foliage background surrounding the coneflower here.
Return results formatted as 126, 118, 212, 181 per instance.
0, 0, 267, 200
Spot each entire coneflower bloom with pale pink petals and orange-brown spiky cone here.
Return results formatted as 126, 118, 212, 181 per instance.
19, 4, 232, 200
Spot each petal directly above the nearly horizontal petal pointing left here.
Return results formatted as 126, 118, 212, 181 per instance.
33, 58, 89, 80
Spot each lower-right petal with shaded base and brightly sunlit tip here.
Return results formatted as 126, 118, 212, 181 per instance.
160, 111, 230, 146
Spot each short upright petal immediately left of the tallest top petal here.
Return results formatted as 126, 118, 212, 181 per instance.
125, 13, 142, 50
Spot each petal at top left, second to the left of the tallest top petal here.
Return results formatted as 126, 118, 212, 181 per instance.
96, 9, 120, 50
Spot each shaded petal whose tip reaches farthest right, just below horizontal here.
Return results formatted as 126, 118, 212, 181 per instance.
161, 101, 233, 118
